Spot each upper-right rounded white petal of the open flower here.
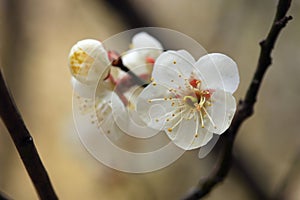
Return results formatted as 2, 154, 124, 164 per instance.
195, 53, 240, 93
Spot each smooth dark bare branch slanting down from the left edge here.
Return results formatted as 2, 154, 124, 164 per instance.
0, 70, 58, 200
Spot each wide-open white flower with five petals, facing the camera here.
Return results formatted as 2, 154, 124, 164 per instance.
137, 50, 239, 150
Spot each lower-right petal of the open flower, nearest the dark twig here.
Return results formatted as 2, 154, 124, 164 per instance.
205, 90, 236, 134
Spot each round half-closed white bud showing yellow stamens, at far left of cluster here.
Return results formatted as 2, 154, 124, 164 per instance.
69, 39, 109, 84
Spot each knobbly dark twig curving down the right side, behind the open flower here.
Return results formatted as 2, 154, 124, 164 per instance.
184, 0, 292, 200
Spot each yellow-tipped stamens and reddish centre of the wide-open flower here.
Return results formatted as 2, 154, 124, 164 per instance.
148, 74, 216, 137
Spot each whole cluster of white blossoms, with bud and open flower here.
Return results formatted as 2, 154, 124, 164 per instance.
69, 32, 239, 158
